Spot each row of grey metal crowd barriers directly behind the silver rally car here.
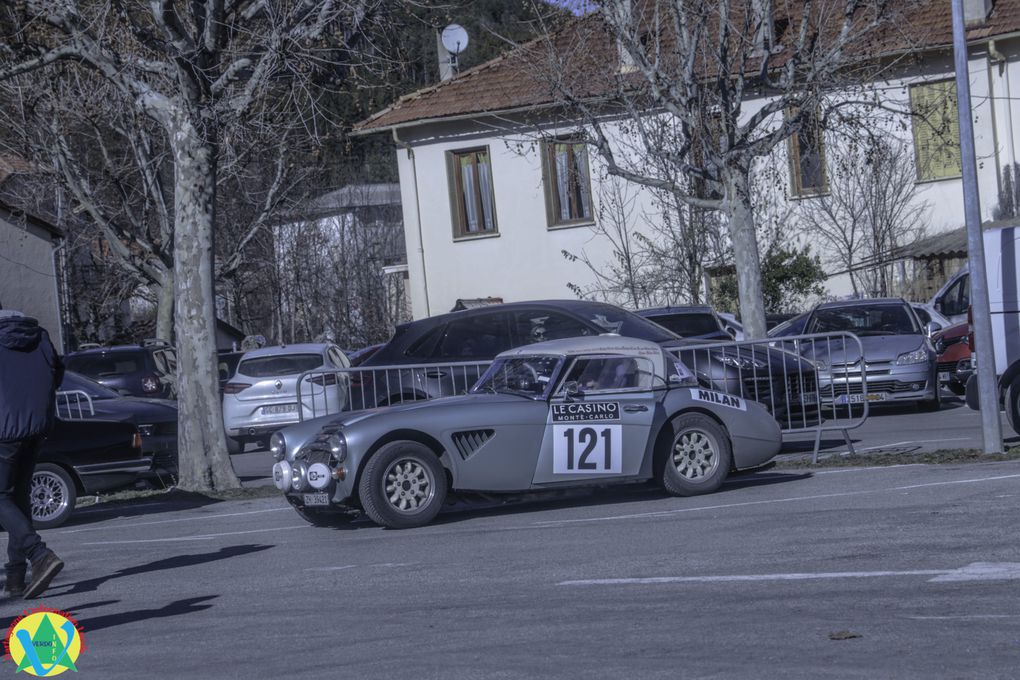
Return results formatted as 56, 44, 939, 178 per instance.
298, 332, 874, 463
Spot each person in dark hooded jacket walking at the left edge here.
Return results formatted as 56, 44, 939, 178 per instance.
0, 307, 63, 599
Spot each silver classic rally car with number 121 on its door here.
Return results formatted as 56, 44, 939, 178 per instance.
270, 335, 780, 528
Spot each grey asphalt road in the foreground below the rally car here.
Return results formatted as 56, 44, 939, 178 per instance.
0, 462, 1020, 680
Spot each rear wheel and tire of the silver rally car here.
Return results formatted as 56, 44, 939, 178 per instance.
662, 413, 733, 495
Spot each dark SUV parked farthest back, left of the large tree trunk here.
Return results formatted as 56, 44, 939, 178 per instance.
64, 341, 177, 399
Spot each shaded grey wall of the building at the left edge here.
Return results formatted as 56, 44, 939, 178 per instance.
0, 211, 63, 351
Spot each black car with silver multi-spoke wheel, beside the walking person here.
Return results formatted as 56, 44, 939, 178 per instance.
31, 419, 152, 529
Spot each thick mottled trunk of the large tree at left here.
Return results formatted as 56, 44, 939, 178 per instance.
173, 114, 241, 490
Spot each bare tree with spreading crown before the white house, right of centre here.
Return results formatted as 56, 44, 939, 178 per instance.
539, 0, 925, 336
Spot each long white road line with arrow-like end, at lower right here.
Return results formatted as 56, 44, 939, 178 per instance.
557, 562, 1020, 585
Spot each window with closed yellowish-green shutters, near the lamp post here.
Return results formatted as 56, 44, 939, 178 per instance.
910, 81, 963, 180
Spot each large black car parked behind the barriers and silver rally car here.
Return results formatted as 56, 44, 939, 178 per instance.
351, 300, 817, 427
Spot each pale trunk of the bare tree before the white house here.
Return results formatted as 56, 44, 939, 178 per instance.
722, 166, 766, 339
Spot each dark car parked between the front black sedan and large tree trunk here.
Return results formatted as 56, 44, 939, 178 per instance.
57, 371, 177, 476
